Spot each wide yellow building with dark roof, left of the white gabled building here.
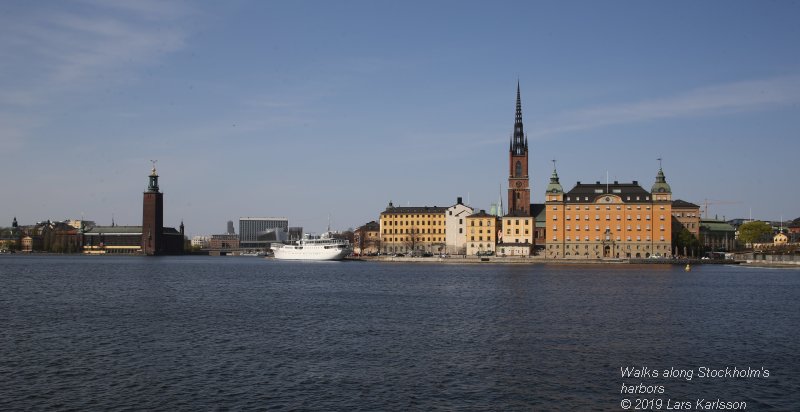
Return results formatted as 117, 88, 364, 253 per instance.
380, 202, 447, 254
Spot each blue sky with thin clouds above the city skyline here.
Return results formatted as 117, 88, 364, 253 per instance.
0, 0, 800, 234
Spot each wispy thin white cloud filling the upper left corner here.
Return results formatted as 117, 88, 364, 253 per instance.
0, 0, 193, 150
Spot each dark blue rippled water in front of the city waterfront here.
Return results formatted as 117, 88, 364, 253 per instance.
0, 256, 800, 411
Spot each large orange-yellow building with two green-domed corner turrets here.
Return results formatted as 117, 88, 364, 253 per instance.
545, 169, 672, 259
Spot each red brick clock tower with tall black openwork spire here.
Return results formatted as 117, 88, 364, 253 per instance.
508, 82, 531, 216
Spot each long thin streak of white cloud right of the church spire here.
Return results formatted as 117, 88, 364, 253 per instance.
531, 75, 800, 137
